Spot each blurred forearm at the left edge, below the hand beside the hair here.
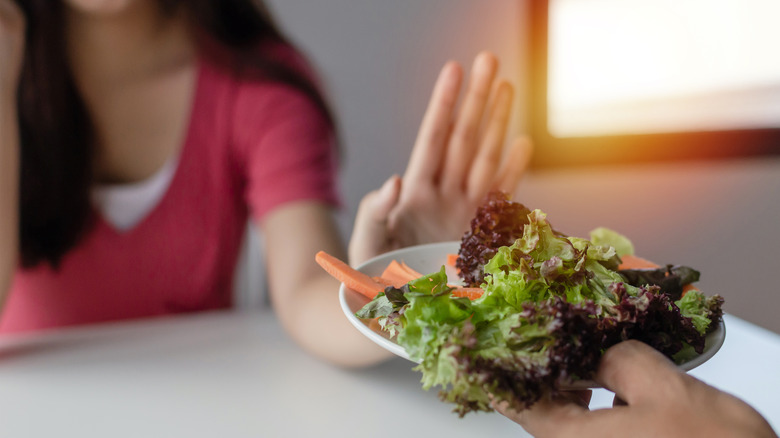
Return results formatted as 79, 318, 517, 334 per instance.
0, 96, 19, 310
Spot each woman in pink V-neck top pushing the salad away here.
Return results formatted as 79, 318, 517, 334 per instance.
0, 0, 529, 365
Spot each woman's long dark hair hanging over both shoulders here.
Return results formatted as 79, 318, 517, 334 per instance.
17, 0, 335, 267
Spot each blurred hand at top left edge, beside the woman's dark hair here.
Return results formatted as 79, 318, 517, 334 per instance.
0, 0, 24, 92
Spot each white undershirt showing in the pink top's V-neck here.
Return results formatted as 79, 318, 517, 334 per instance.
92, 154, 179, 231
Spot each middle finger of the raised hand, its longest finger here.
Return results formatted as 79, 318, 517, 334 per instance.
441, 52, 498, 192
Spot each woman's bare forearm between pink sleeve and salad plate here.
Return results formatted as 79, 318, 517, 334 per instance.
259, 201, 390, 367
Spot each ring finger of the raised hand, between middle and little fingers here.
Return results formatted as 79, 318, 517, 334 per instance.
467, 82, 514, 199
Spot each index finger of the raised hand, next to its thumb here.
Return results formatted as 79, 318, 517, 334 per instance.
404, 62, 463, 187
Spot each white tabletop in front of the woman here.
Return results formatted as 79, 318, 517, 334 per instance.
0, 311, 780, 438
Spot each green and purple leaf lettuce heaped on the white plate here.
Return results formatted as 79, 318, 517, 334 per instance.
356, 193, 723, 416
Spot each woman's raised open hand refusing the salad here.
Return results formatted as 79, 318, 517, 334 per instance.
349, 53, 532, 264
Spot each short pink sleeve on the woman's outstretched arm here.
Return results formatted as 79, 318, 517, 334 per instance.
233, 83, 340, 219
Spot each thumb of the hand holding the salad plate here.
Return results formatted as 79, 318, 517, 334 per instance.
596, 341, 684, 405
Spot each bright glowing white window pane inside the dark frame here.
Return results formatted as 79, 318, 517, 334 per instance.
548, 0, 780, 137
